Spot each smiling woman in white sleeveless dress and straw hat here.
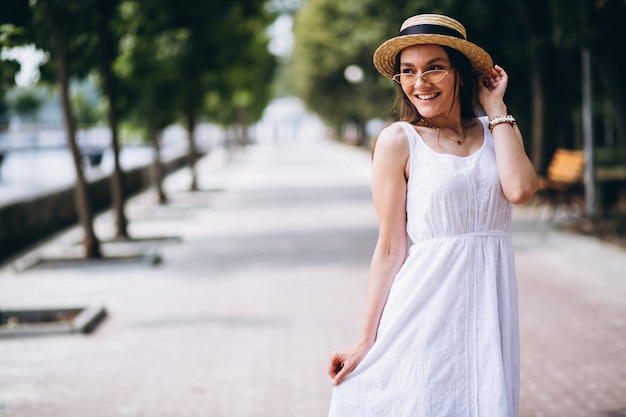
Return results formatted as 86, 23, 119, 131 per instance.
329, 14, 537, 417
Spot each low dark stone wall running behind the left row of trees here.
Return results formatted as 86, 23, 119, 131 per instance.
0, 155, 187, 261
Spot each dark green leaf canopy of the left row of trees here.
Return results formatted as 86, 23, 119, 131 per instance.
0, 0, 278, 143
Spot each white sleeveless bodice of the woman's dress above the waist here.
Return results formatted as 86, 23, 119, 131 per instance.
398, 117, 512, 242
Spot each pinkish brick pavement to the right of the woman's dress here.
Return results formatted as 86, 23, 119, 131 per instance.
514, 213, 626, 417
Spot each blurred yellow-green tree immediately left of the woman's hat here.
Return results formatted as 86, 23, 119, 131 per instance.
291, 0, 397, 145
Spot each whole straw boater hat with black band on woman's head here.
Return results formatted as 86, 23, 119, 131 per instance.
374, 14, 493, 78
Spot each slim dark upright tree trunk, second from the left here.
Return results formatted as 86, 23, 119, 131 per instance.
98, 0, 128, 239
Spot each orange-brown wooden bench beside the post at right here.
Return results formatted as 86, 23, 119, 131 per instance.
535, 148, 585, 215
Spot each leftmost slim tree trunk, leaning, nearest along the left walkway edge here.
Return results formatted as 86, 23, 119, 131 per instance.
45, 0, 102, 258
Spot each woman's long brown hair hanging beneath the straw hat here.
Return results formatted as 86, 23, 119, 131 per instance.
394, 45, 476, 123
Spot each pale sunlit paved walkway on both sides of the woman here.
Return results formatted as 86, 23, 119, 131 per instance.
0, 138, 626, 417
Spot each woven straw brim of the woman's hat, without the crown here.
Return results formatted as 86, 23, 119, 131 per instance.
374, 34, 493, 78
